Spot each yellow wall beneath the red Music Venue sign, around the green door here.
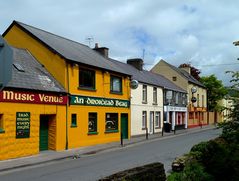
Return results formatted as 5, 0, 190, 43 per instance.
0, 102, 66, 160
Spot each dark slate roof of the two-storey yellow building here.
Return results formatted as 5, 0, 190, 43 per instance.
3, 21, 131, 75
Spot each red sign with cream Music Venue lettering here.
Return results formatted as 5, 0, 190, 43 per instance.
0, 90, 67, 104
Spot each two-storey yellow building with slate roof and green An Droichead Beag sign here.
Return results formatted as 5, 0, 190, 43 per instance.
3, 21, 130, 149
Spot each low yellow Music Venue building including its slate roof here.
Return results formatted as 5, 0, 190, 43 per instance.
0, 45, 67, 160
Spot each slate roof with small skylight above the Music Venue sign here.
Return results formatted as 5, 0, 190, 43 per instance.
6, 47, 66, 93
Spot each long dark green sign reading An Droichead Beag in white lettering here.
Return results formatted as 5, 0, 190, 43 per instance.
70, 95, 130, 108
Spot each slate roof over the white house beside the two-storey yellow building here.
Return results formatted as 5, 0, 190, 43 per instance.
110, 59, 187, 93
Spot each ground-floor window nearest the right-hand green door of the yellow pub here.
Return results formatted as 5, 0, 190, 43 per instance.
105, 113, 118, 132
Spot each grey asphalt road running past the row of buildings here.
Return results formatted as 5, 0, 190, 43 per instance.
0, 129, 221, 181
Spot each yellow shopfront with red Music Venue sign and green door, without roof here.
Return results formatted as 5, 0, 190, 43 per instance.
0, 89, 67, 160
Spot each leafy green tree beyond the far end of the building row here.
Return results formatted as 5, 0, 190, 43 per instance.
200, 75, 227, 111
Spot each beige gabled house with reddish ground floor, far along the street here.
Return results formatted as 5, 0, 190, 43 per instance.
151, 60, 207, 128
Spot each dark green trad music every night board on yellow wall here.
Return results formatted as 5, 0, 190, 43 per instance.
16, 112, 30, 138
